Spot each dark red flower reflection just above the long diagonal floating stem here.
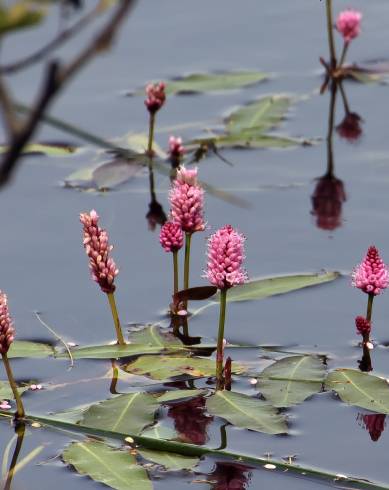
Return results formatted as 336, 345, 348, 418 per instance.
168, 397, 212, 444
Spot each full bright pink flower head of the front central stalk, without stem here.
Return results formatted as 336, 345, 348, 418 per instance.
205, 225, 247, 289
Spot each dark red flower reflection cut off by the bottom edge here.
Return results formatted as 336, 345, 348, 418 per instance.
208, 463, 251, 490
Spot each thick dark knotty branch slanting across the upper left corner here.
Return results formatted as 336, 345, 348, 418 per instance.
0, 0, 135, 186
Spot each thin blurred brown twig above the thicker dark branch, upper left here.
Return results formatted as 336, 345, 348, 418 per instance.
0, 4, 102, 75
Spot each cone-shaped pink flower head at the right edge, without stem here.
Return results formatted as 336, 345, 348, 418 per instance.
351, 246, 389, 296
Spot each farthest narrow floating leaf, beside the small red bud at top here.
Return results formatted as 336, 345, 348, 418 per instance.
134, 71, 269, 95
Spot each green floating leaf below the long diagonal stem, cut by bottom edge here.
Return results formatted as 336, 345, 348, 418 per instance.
62, 441, 153, 490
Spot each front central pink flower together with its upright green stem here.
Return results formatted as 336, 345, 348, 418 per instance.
205, 225, 247, 390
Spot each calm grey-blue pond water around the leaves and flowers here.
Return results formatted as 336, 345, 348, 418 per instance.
0, 0, 389, 490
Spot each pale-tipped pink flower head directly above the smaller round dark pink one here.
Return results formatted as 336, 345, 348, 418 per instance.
169, 167, 205, 233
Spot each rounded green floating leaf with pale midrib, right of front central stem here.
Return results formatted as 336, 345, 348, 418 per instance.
258, 356, 325, 407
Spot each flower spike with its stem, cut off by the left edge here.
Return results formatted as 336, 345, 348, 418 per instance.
0, 291, 25, 419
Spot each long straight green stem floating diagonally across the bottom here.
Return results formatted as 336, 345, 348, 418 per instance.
0, 410, 389, 490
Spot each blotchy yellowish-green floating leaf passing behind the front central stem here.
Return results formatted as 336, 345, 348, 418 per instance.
124, 356, 244, 380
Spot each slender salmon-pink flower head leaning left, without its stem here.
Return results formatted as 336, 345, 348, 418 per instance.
80, 210, 119, 293
